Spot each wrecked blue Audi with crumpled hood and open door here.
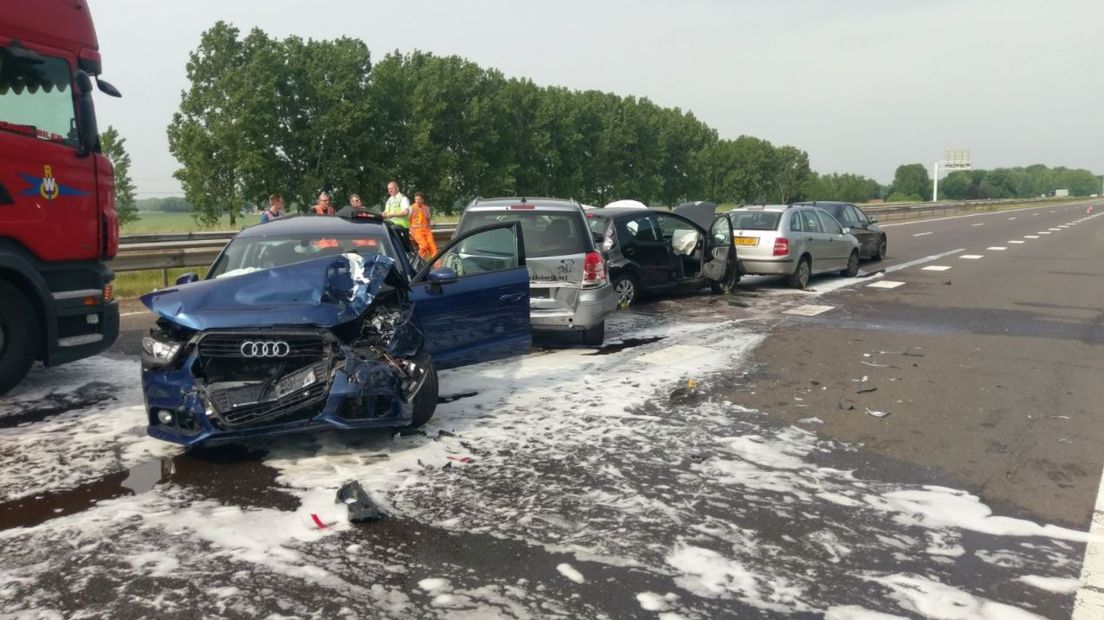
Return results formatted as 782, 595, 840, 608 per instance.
141, 209, 531, 447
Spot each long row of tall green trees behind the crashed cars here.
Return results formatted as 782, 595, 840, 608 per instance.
168, 22, 877, 220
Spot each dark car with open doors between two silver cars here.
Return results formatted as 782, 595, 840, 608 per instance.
586, 202, 740, 308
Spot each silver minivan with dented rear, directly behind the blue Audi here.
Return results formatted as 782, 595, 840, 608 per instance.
457, 197, 617, 346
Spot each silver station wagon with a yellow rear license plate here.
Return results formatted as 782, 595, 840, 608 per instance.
728, 204, 859, 289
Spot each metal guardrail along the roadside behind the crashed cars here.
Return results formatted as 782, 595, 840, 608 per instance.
108, 199, 1083, 274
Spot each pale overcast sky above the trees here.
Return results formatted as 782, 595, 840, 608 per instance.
89, 0, 1104, 197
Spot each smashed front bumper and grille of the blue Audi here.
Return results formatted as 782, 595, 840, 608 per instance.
142, 329, 429, 447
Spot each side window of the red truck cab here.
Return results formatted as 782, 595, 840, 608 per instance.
0, 47, 78, 147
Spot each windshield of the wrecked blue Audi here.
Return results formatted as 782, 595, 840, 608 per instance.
208, 229, 394, 278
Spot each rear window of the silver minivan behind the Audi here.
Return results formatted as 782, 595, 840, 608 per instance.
459, 211, 591, 258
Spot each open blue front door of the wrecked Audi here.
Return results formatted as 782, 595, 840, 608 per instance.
411, 222, 532, 370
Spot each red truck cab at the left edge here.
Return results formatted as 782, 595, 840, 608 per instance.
0, 0, 119, 394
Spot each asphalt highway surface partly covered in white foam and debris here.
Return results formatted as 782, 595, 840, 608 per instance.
0, 204, 1104, 619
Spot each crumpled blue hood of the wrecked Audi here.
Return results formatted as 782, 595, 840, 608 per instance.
141, 254, 395, 331
